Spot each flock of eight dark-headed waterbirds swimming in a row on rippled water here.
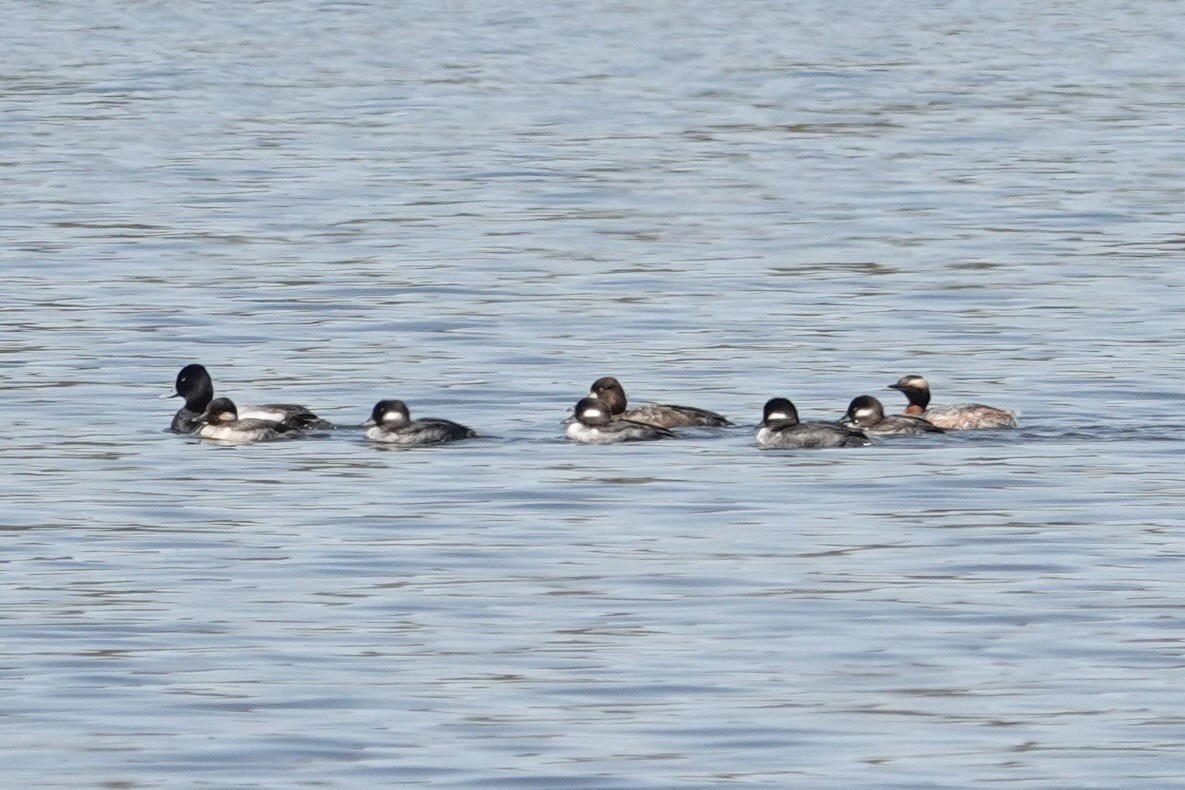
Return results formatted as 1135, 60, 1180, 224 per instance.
161, 365, 1017, 449
